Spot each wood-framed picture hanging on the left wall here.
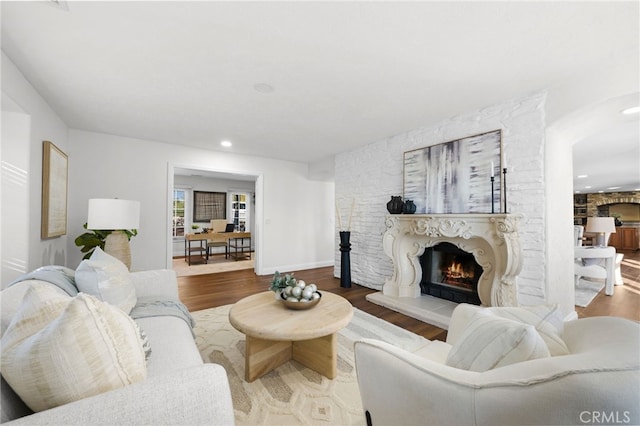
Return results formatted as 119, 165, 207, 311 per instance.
41, 141, 69, 239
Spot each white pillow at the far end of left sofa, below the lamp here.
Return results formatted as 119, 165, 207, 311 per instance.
76, 247, 137, 314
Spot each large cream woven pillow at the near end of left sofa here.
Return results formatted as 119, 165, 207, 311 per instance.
1, 289, 147, 411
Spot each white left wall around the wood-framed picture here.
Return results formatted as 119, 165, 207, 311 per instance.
2, 52, 69, 280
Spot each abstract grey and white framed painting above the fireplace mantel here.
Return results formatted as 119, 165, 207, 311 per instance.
403, 130, 504, 214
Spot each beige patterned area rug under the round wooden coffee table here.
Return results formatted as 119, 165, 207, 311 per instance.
192, 305, 429, 426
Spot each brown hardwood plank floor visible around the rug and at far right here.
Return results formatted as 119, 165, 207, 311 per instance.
178, 251, 640, 340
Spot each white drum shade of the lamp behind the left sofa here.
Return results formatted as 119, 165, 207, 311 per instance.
87, 198, 140, 230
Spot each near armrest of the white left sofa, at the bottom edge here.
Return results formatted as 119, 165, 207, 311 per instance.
5, 364, 235, 426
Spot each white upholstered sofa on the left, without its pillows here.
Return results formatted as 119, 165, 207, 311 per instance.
1, 264, 234, 425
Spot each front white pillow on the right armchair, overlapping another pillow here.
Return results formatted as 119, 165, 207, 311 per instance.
446, 311, 550, 372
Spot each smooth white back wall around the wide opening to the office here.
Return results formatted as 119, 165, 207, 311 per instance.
68, 130, 334, 274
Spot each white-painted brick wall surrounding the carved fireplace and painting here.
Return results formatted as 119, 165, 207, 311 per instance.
334, 93, 552, 305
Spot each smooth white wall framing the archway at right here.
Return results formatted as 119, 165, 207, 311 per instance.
545, 50, 640, 317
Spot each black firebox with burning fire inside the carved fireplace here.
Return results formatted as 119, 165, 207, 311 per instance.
420, 242, 483, 305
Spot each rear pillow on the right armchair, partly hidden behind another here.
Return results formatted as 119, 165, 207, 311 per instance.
488, 305, 569, 356
